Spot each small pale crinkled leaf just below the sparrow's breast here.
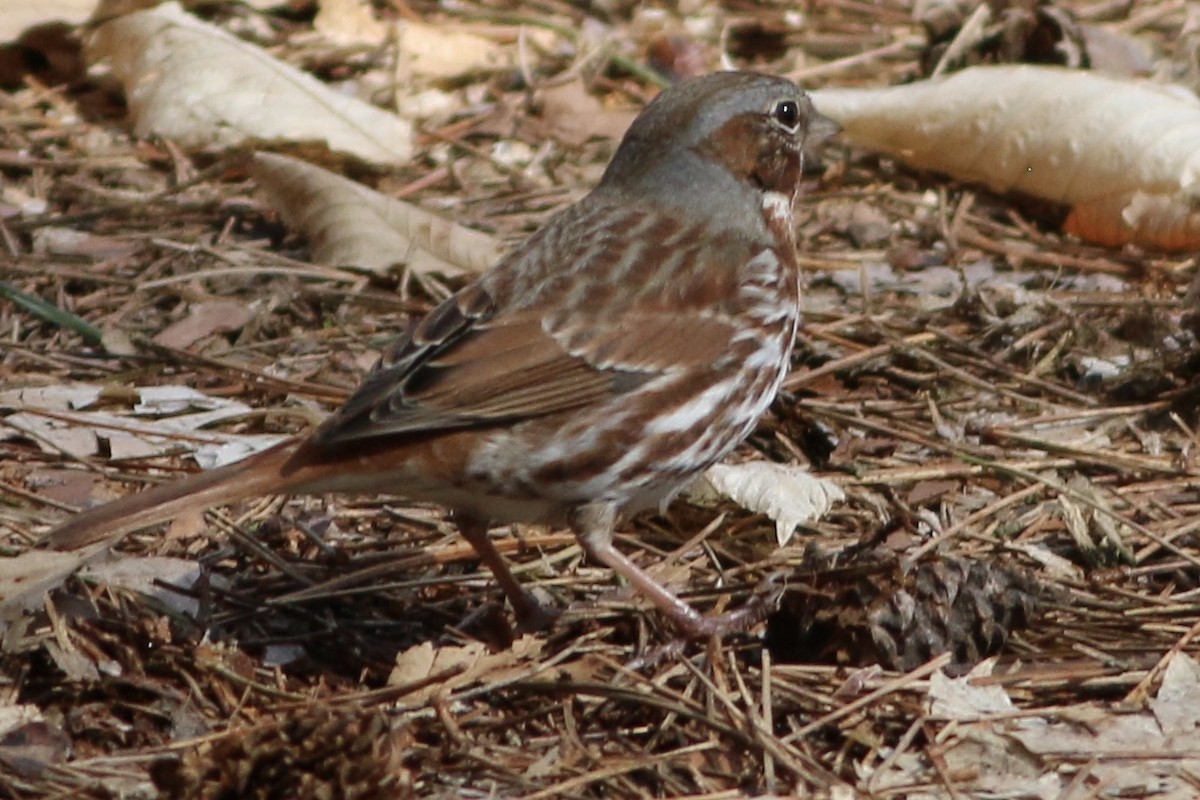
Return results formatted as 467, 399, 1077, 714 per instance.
688, 461, 846, 547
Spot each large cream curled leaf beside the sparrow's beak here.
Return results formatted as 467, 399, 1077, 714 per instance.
812, 65, 1200, 249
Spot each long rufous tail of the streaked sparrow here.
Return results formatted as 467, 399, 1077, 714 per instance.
42, 440, 302, 549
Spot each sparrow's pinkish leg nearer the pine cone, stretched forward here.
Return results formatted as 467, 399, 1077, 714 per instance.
571, 504, 769, 639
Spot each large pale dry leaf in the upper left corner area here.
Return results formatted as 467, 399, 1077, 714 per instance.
88, 2, 413, 163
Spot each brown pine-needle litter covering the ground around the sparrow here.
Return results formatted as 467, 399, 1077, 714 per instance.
0, 0, 1200, 799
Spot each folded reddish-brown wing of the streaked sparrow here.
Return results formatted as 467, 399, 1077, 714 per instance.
314, 244, 737, 445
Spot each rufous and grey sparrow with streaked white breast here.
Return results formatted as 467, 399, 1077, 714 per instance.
43, 71, 838, 638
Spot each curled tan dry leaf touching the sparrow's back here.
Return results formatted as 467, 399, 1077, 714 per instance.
253, 152, 505, 275
